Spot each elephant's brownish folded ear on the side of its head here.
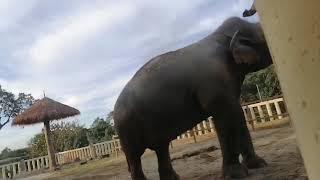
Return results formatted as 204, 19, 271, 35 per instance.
230, 31, 260, 65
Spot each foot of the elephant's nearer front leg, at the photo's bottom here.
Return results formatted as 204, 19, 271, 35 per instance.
223, 163, 249, 180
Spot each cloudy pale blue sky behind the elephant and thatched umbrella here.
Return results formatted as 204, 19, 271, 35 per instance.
0, 0, 257, 151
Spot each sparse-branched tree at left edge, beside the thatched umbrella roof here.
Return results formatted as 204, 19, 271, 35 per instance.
0, 86, 35, 130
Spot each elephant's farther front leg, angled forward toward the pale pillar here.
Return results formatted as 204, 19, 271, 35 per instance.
239, 107, 267, 169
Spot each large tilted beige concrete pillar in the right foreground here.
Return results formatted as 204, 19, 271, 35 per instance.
255, 0, 320, 180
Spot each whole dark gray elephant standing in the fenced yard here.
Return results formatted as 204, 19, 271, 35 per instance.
114, 18, 272, 180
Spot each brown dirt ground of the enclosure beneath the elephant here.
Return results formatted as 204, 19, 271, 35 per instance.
38, 126, 308, 180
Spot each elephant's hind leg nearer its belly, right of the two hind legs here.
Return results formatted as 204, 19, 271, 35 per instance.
155, 143, 180, 180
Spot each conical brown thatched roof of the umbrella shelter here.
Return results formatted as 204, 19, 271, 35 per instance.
12, 97, 80, 125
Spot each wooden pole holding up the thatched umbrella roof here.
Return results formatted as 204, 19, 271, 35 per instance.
44, 121, 57, 170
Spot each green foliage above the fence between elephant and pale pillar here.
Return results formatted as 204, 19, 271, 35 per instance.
241, 66, 282, 102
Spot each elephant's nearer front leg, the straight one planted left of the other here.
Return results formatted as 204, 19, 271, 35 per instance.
214, 103, 248, 179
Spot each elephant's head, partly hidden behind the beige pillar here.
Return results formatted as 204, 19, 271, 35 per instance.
220, 18, 272, 73
